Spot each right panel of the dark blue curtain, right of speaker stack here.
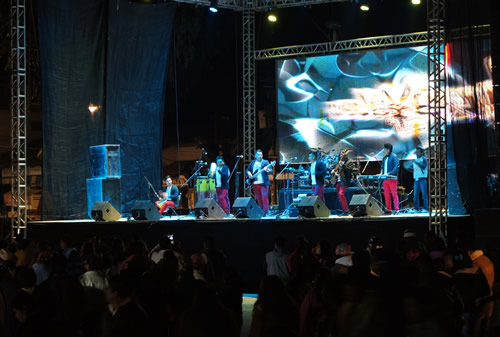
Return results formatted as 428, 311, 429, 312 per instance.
106, 0, 175, 213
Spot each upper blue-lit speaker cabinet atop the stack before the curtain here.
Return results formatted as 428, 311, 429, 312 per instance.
89, 144, 122, 178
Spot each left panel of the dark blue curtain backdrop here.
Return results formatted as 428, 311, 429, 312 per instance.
36, 0, 105, 219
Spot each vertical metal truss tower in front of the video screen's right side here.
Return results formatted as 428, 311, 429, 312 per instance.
427, 0, 448, 237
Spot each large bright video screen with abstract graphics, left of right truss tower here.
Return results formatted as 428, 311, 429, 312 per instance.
276, 46, 428, 162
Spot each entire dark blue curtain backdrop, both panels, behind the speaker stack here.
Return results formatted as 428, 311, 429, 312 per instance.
36, 0, 175, 219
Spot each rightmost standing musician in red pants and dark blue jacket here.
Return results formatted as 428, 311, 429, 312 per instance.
380, 143, 399, 213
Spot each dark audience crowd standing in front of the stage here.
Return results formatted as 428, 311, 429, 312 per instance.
0, 232, 500, 337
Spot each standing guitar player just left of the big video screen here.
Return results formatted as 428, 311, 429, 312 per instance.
247, 149, 273, 214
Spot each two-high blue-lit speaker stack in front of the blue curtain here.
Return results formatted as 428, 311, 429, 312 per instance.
87, 144, 122, 221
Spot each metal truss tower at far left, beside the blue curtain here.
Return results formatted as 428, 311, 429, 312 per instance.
10, 0, 28, 239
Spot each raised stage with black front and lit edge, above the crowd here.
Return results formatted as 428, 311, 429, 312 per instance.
28, 213, 474, 291
